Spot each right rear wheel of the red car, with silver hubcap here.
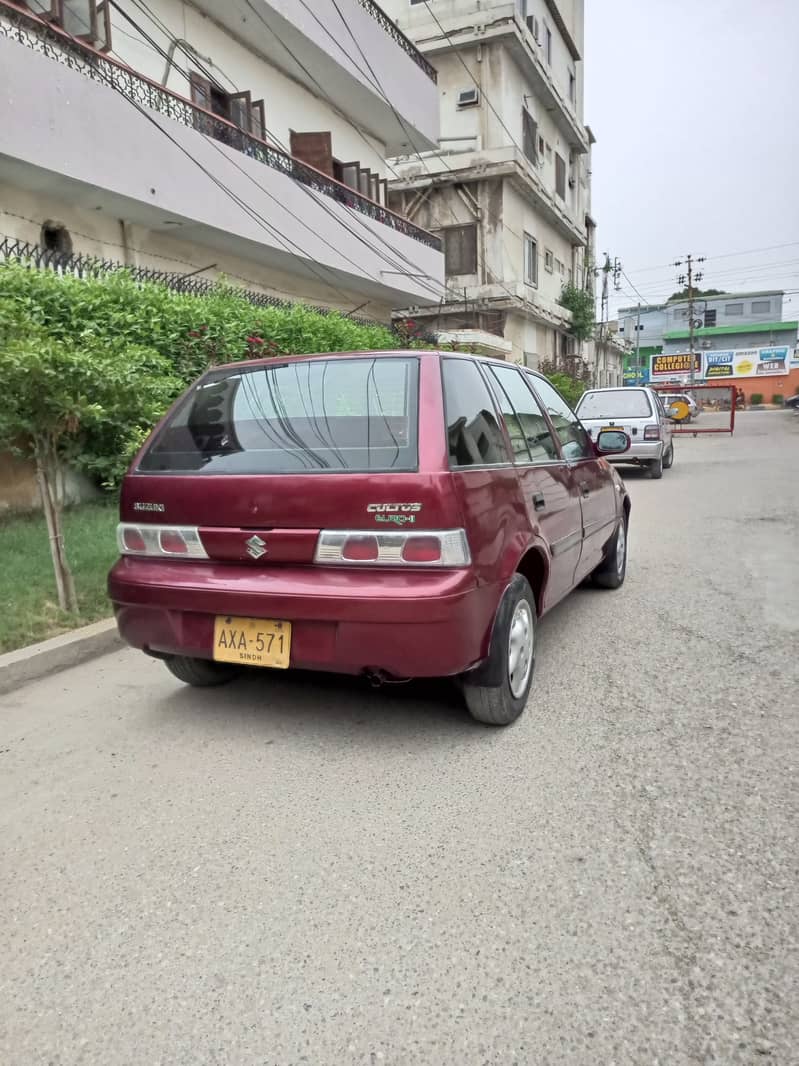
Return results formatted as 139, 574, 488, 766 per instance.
462, 574, 536, 726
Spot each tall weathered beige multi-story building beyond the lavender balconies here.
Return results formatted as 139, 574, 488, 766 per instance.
384, 0, 593, 366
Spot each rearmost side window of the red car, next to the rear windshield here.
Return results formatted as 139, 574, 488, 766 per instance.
441, 359, 510, 467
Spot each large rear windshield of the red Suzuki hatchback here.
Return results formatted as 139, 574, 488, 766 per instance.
138, 357, 419, 474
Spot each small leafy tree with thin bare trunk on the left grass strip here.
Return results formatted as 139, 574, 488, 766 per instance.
0, 301, 181, 612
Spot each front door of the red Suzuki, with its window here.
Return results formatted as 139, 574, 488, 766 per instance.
525, 371, 621, 584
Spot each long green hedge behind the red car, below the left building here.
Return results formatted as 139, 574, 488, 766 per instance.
0, 261, 398, 485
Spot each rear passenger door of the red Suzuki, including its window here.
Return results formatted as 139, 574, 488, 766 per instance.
485, 364, 583, 609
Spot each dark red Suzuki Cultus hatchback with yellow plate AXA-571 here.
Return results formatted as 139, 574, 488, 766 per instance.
109, 351, 630, 725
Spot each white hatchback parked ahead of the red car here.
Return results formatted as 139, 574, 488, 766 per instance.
577, 386, 674, 479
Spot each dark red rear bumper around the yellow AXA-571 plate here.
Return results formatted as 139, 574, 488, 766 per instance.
109, 558, 502, 677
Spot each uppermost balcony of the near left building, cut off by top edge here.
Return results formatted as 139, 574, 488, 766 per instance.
193, 0, 438, 156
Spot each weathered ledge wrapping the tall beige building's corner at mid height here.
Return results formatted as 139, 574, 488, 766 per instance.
389, 145, 587, 246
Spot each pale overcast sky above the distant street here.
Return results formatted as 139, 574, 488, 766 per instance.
585, 0, 799, 319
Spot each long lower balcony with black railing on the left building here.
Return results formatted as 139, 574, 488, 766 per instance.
0, 0, 443, 305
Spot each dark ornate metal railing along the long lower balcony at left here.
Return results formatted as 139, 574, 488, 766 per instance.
0, 0, 441, 252
